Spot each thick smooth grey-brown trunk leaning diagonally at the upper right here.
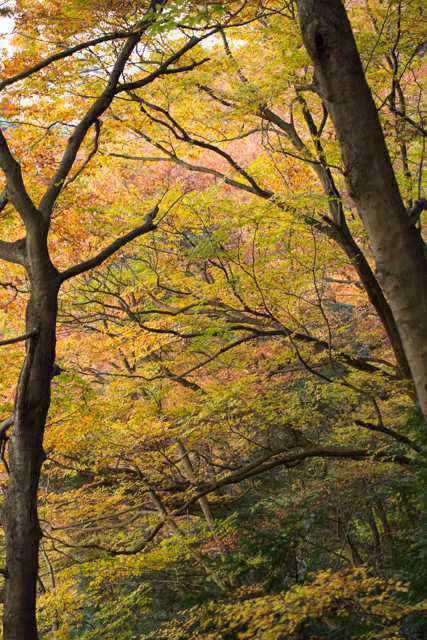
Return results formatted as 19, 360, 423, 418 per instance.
299, 0, 427, 417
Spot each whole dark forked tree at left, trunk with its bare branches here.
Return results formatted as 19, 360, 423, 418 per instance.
0, 0, 260, 640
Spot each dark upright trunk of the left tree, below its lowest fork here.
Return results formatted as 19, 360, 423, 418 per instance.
3, 270, 58, 640
